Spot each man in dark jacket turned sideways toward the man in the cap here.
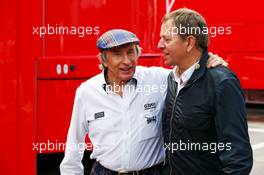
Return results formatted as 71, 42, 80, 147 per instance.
158, 8, 253, 175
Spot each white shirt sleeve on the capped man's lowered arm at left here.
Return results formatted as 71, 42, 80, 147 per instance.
60, 88, 88, 175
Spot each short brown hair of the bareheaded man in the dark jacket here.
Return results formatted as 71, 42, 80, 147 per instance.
162, 8, 209, 49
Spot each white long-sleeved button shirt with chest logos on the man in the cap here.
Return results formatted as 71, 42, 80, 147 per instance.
60, 66, 171, 175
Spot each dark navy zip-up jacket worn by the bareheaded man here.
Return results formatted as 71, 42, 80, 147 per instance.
163, 51, 253, 175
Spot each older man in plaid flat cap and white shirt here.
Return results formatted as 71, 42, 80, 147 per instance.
60, 29, 227, 175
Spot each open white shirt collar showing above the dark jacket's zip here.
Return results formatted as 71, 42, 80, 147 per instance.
172, 61, 199, 96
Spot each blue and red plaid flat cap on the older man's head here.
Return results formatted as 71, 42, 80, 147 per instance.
96, 29, 139, 50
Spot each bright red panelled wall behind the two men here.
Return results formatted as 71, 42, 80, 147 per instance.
0, 0, 264, 175
